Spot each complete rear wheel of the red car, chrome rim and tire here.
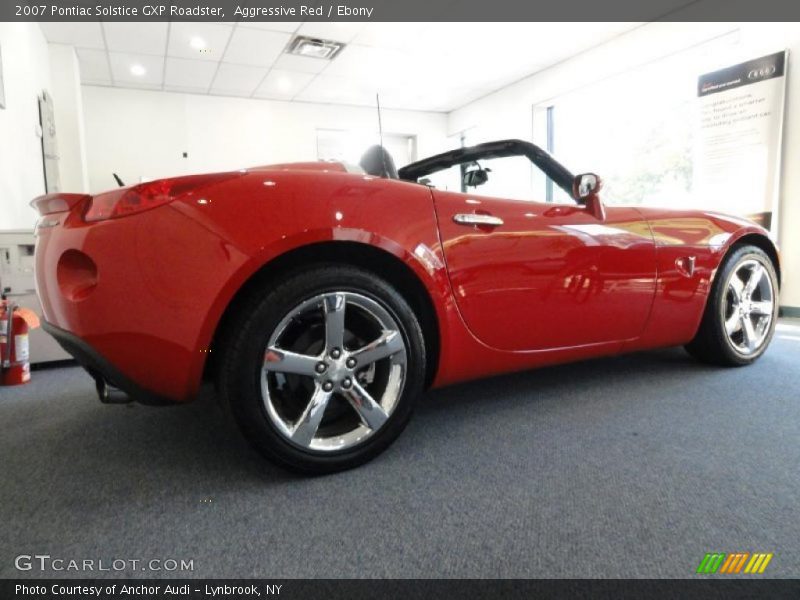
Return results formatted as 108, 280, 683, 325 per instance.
212, 265, 425, 473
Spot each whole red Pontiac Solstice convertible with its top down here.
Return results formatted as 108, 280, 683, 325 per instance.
32, 140, 780, 473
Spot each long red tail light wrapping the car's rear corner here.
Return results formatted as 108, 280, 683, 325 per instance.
83, 173, 241, 222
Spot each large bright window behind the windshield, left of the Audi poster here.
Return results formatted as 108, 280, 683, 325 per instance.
534, 36, 731, 207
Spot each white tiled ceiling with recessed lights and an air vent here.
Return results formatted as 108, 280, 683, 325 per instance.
40, 22, 639, 112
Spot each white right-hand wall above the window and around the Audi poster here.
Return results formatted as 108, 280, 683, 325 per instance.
448, 23, 800, 307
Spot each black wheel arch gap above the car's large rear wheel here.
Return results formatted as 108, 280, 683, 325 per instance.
204, 240, 441, 387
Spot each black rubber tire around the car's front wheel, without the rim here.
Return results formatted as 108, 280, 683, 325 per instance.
685, 245, 778, 367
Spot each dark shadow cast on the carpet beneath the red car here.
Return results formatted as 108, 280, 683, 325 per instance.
15, 342, 728, 489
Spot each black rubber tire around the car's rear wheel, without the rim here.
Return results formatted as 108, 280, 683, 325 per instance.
212, 263, 426, 474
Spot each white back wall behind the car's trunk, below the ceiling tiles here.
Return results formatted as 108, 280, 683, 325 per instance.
81, 86, 447, 192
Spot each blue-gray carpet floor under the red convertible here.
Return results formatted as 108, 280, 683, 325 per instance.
0, 321, 800, 577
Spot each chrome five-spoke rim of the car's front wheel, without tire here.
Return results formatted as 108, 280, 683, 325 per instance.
723, 258, 775, 355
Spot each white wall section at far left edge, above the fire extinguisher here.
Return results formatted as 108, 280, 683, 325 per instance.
0, 23, 50, 230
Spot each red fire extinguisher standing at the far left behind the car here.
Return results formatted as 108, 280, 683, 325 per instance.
0, 290, 39, 385
